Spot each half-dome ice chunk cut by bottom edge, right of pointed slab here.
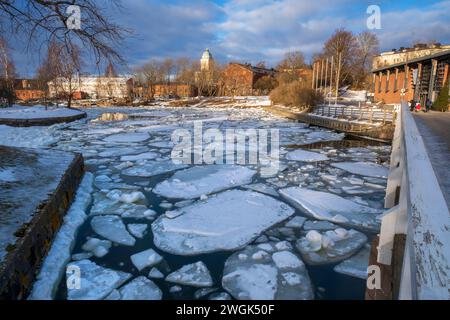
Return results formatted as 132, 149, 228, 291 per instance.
119, 277, 162, 300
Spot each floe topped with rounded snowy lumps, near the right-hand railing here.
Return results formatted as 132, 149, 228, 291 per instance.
296, 228, 367, 265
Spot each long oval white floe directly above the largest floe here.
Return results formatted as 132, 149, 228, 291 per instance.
153, 165, 256, 199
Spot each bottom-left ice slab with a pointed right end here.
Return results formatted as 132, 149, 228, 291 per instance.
67, 260, 131, 300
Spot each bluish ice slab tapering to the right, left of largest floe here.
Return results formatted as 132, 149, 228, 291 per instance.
91, 216, 136, 246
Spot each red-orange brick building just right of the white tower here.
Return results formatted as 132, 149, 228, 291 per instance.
222, 63, 276, 96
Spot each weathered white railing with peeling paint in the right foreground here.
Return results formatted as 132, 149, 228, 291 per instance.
378, 103, 450, 300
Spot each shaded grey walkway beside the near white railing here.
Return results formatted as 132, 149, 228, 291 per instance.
414, 111, 450, 208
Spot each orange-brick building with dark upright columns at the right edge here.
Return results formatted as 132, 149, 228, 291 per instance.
372, 48, 450, 104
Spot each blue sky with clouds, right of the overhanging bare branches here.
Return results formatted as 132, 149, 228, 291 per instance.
9, 0, 450, 76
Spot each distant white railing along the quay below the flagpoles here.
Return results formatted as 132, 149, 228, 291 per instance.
311, 105, 395, 123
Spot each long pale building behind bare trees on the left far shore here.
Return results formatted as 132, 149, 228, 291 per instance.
48, 76, 133, 99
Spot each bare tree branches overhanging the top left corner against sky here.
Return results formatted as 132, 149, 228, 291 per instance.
0, 0, 129, 63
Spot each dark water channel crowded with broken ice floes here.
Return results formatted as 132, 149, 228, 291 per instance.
9, 106, 390, 299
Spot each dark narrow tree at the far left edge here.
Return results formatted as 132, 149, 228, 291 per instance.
0, 36, 16, 106
